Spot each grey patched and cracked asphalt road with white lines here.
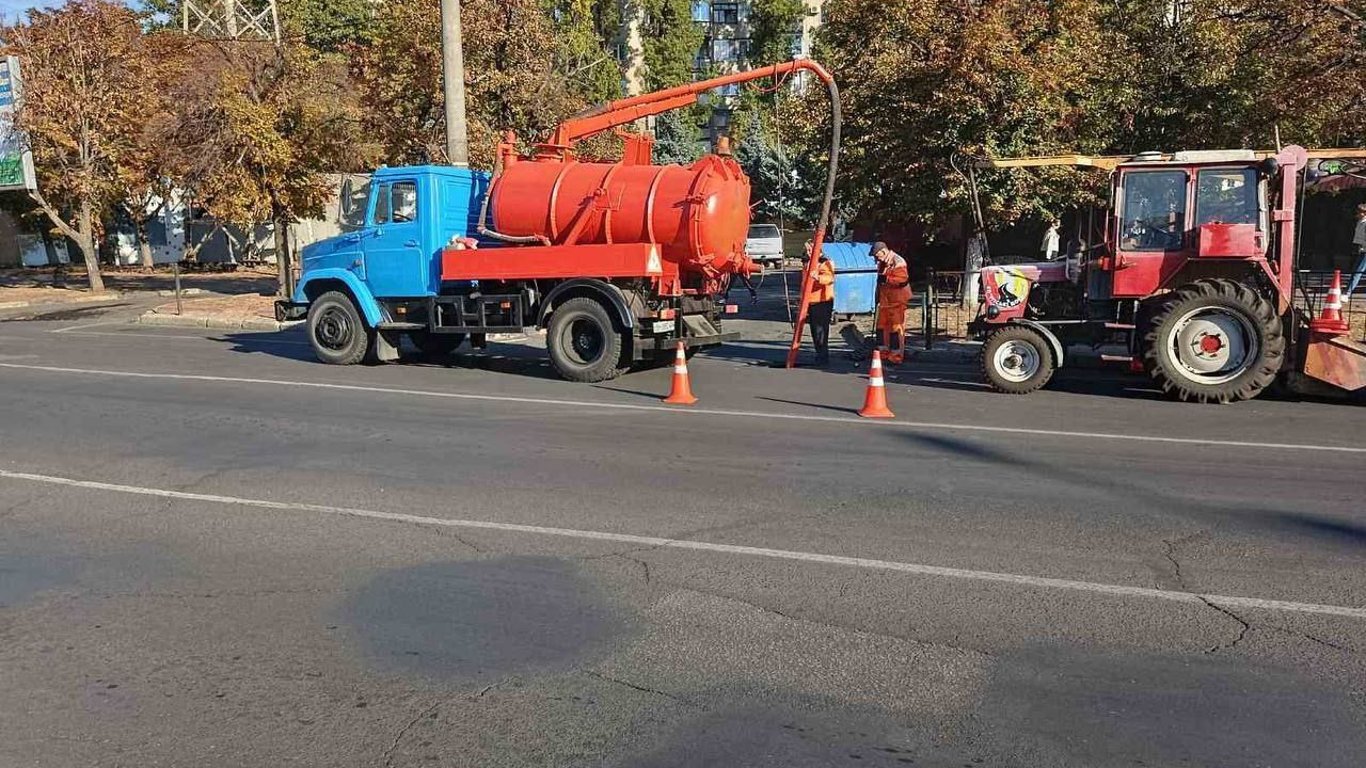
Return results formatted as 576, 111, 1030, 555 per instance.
0, 296, 1366, 768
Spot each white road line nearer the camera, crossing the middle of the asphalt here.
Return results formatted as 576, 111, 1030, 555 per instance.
0, 469, 1366, 619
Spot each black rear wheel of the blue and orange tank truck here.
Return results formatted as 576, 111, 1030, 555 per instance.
545, 297, 623, 383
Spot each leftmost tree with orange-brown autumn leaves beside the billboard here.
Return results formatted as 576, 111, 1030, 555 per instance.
0, 0, 168, 291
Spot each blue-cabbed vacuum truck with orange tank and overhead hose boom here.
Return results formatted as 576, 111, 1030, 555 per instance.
276, 59, 839, 383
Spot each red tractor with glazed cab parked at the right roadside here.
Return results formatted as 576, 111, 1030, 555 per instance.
971, 146, 1366, 403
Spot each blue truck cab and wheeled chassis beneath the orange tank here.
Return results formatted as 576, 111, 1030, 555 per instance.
276, 165, 736, 381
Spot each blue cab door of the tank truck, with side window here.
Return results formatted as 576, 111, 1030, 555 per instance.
362, 175, 432, 298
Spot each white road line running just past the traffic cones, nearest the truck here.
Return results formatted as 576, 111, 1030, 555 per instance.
0, 362, 1366, 454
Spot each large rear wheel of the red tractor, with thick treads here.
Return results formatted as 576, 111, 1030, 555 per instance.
1141, 279, 1285, 403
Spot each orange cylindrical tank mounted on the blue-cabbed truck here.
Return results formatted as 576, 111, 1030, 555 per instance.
490, 154, 753, 277
